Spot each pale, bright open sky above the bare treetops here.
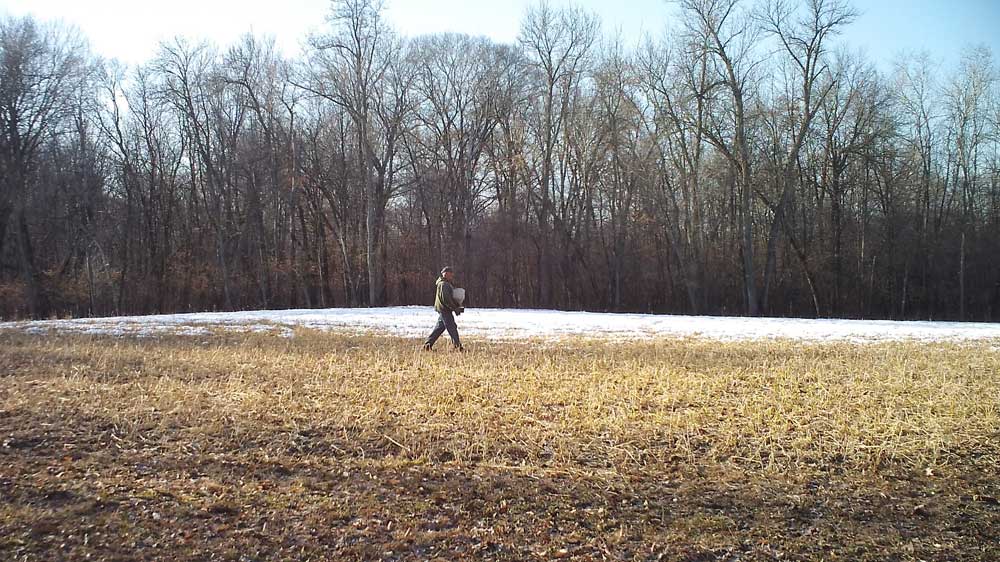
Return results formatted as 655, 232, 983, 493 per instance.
0, 0, 1000, 69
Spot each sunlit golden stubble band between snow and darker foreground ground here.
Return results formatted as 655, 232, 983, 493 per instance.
0, 331, 1000, 471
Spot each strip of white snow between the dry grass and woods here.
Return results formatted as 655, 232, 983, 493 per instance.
0, 306, 1000, 342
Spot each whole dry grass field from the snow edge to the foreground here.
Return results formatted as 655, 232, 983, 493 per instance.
0, 330, 1000, 562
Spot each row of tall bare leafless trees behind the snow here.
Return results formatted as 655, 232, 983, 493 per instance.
0, 0, 1000, 320
